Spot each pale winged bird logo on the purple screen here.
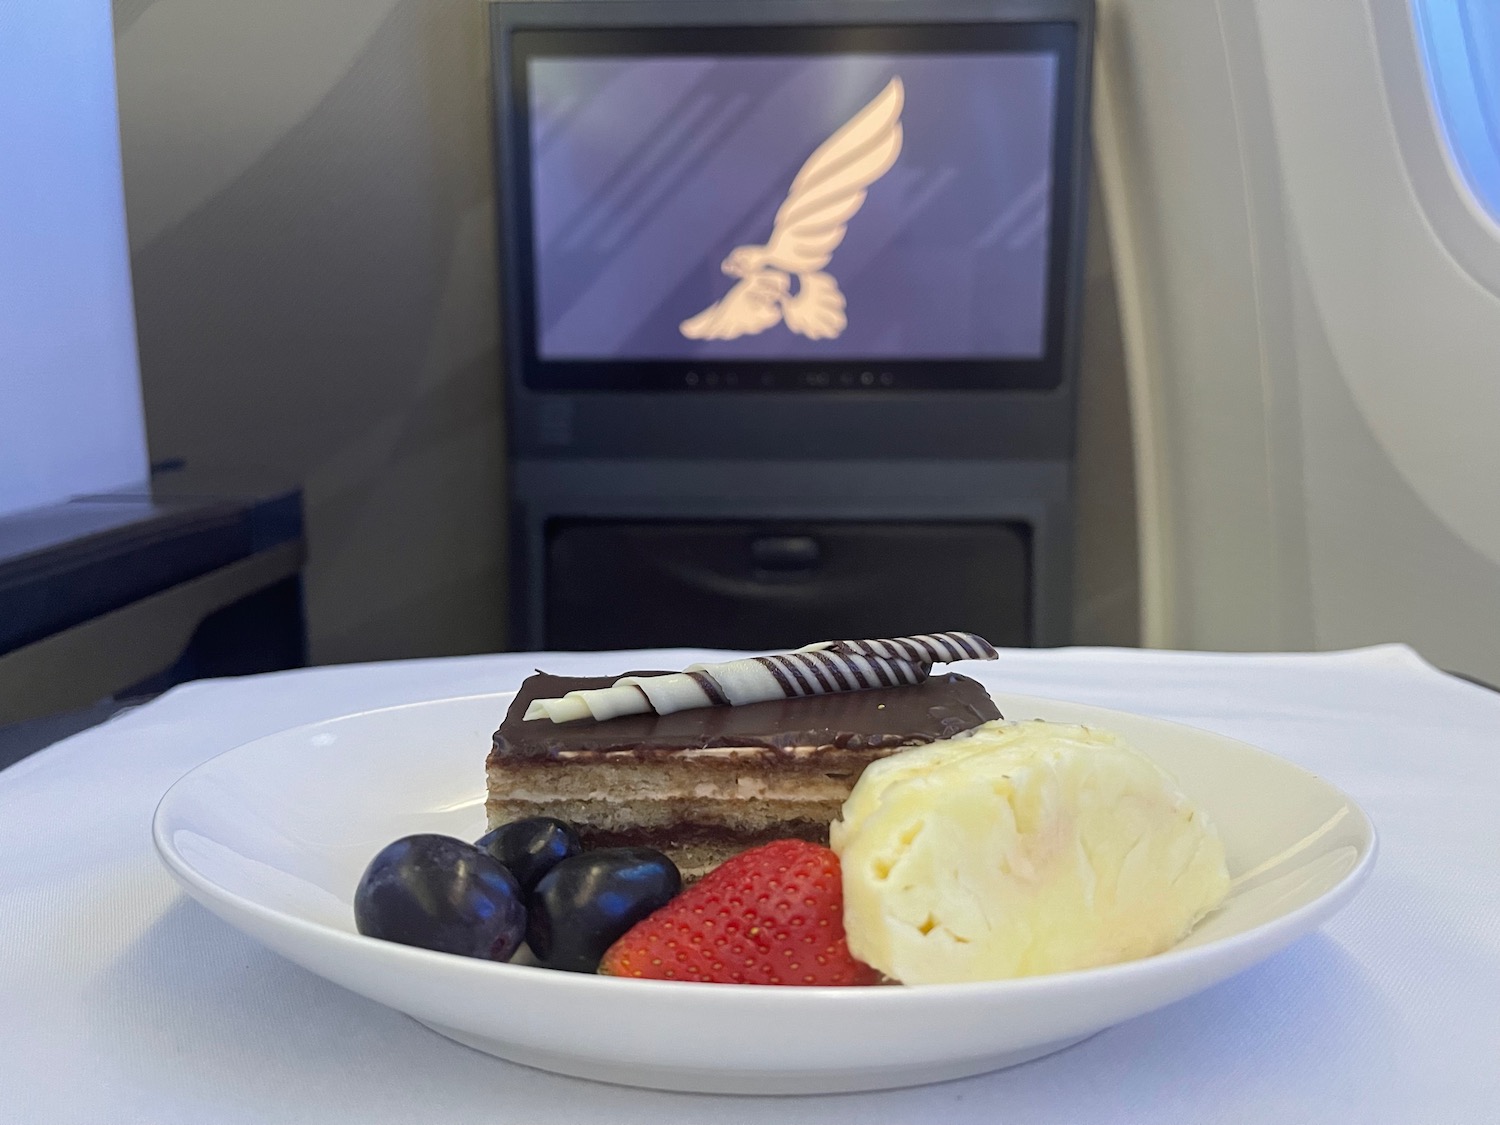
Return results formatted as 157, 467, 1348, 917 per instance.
678, 78, 906, 341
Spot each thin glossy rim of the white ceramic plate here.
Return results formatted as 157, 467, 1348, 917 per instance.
152, 686, 1380, 1007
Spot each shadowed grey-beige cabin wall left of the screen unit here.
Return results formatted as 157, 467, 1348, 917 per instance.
114, 0, 506, 663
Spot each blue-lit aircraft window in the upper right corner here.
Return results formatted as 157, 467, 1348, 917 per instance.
1412, 0, 1500, 219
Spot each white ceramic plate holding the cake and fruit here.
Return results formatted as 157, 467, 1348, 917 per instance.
153, 693, 1376, 1094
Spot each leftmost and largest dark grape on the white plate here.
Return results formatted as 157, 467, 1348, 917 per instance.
354, 834, 527, 962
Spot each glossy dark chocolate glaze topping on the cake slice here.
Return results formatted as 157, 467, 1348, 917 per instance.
494, 672, 1001, 759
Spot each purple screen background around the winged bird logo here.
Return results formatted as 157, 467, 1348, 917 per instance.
530, 54, 1056, 360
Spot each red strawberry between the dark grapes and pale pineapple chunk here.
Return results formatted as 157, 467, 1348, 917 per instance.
599, 840, 879, 984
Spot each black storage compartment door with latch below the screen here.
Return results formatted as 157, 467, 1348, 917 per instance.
543, 521, 1032, 650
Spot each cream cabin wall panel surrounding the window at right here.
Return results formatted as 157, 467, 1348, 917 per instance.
1100, 0, 1500, 681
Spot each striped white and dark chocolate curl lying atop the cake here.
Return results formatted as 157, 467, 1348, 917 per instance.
524, 633, 999, 723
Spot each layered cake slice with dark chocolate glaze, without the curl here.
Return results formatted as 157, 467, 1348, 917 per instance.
486, 672, 999, 878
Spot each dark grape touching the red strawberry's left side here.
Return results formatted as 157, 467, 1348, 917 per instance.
527, 848, 683, 972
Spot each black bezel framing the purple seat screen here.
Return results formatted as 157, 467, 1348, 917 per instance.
504, 21, 1079, 392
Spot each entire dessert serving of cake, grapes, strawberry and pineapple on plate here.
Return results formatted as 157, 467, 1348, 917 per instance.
356, 633, 1229, 986
